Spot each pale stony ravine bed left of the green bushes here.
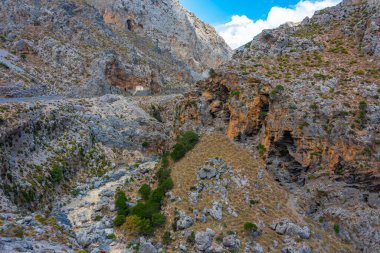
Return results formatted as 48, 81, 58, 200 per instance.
61, 162, 156, 253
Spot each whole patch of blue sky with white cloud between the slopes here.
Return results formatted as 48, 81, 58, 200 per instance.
180, 0, 341, 49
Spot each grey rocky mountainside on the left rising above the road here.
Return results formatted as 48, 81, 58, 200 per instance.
0, 0, 231, 97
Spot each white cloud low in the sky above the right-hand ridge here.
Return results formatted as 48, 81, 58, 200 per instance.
215, 0, 341, 49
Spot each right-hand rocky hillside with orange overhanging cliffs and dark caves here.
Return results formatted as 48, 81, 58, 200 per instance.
189, 1, 380, 252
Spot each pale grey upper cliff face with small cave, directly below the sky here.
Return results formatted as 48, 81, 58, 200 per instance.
87, 0, 232, 74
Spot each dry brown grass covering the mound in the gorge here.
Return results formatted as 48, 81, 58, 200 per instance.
156, 134, 354, 252
